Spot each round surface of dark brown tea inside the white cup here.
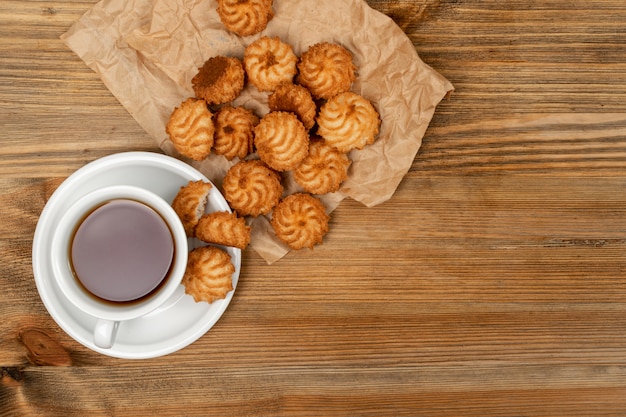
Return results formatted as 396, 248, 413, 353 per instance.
70, 200, 174, 302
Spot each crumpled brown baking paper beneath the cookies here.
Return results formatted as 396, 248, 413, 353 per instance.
61, 0, 453, 263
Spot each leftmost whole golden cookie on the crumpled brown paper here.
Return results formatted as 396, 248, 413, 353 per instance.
165, 98, 215, 161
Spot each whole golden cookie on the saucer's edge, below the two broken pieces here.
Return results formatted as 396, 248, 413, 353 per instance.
183, 245, 235, 303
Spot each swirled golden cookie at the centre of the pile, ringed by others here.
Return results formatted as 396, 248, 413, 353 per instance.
254, 112, 309, 171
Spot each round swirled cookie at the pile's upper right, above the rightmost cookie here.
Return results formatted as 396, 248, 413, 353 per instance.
297, 42, 356, 99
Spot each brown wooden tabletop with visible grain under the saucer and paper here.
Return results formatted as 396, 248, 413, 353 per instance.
0, 0, 626, 417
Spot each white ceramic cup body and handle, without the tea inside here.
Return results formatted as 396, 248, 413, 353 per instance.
50, 185, 188, 349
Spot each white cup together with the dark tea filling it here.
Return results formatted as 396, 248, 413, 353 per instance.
51, 186, 188, 348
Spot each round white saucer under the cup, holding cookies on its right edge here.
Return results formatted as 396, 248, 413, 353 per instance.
33, 152, 241, 359
